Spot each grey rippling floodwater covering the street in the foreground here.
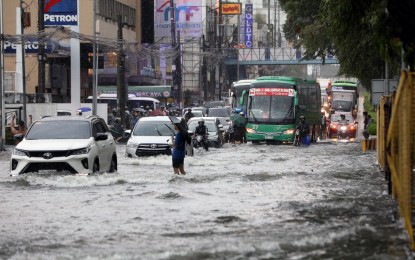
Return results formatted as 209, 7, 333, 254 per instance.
0, 143, 411, 260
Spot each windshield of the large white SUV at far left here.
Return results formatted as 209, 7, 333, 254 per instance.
26, 120, 91, 140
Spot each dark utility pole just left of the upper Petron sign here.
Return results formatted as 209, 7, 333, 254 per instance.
37, 0, 46, 93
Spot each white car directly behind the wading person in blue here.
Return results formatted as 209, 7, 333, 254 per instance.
125, 116, 193, 158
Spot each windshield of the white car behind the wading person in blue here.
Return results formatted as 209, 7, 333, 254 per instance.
133, 121, 175, 136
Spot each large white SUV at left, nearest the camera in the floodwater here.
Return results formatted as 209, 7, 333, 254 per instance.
10, 116, 117, 176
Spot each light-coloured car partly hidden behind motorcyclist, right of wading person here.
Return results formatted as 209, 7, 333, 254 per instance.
187, 117, 225, 148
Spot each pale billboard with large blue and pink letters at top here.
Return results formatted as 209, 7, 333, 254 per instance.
154, 0, 203, 39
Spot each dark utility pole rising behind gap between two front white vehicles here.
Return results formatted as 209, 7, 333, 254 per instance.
117, 14, 127, 127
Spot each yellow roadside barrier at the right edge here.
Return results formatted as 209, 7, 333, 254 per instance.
377, 71, 415, 250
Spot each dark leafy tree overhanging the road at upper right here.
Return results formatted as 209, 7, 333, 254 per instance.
280, 0, 415, 87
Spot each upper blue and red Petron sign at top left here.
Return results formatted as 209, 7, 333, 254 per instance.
43, 0, 78, 26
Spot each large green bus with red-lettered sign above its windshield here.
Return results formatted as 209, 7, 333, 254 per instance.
241, 76, 322, 143
